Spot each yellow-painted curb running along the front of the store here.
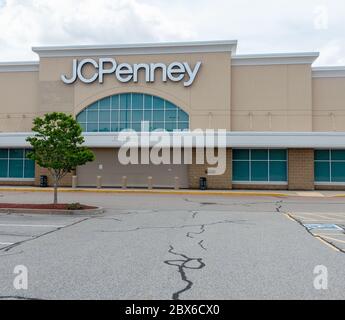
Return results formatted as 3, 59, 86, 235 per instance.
0, 187, 292, 197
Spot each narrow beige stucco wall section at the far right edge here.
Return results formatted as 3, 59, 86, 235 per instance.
313, 78, 345, 131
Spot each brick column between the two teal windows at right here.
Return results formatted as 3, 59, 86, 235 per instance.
288, 149, 314, 190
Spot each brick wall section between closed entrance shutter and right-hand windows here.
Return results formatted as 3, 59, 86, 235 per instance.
188, 148, 232, 189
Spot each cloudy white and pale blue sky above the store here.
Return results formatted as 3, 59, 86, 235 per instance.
0, 0, 345, 65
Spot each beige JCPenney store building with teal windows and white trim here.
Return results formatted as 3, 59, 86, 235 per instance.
0, 41, 345, 190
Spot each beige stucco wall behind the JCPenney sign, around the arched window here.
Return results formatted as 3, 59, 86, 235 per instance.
39, 53, 231, 130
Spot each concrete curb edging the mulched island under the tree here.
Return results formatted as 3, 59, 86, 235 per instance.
0, 207, 105, 216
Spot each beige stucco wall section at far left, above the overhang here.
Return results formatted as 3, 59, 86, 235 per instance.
0, 72, 38, 132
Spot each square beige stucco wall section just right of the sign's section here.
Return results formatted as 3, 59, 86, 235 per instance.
231, 64, 312, 131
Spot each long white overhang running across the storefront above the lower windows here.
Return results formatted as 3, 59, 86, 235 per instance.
0, 132, 345, 149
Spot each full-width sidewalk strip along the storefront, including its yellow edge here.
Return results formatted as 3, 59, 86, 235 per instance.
0, 186, 345, 198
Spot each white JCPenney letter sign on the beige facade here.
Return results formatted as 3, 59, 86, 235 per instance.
61, 58, 201, 87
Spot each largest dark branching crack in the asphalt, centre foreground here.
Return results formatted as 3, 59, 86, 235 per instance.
164, 245, 206, 300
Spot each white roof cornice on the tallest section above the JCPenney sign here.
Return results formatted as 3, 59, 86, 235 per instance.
32, 40, 237, 57
